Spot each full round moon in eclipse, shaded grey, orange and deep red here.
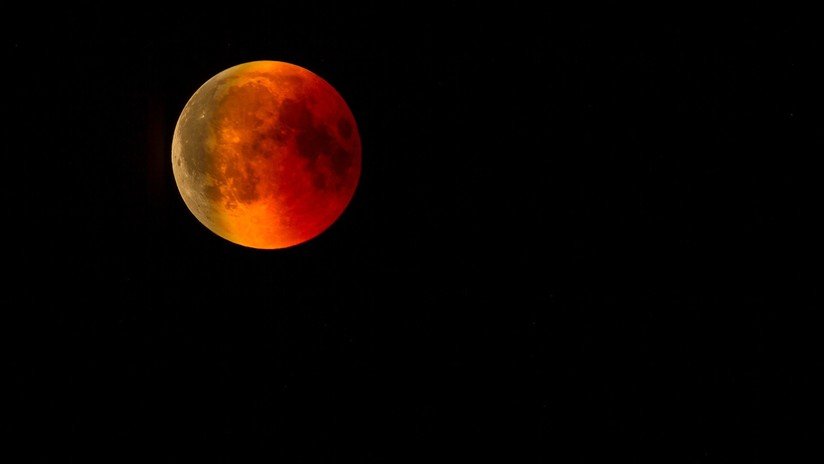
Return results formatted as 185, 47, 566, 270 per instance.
172, 61, 361, 249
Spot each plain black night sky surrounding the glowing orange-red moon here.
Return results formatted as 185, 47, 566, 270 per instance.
8, 3, 824, 463
